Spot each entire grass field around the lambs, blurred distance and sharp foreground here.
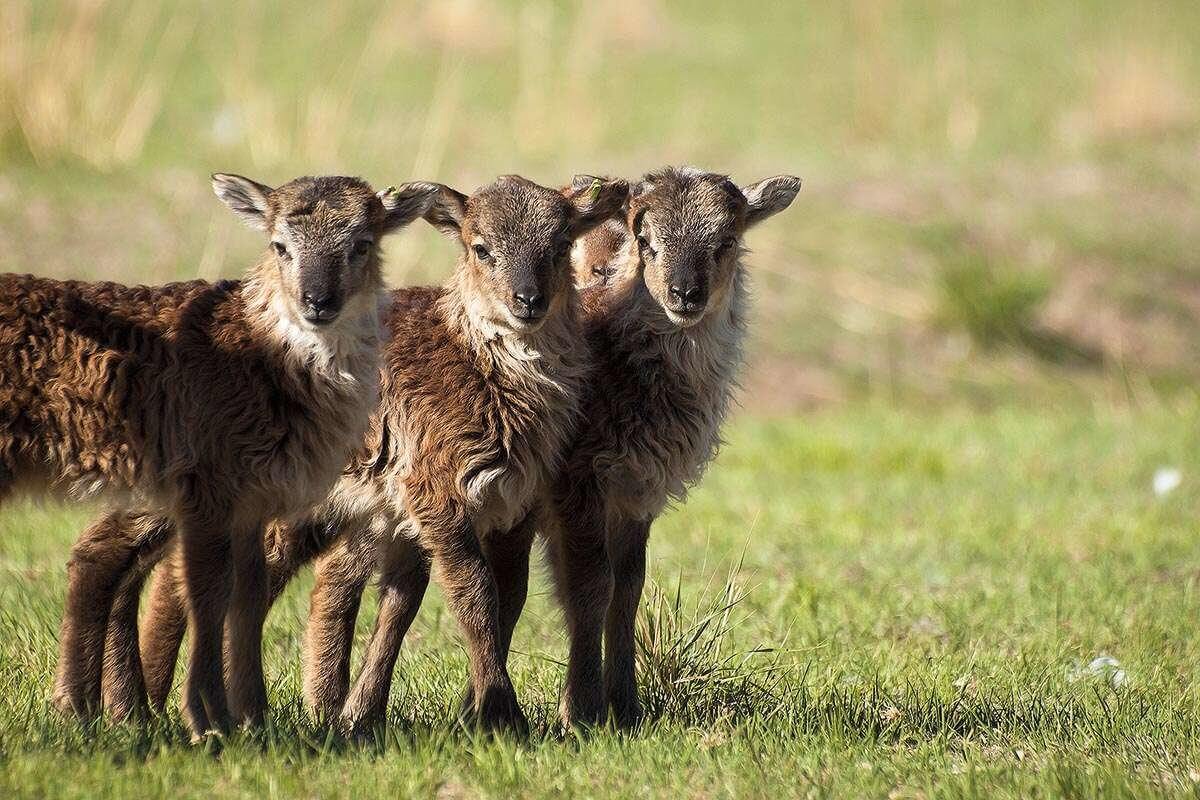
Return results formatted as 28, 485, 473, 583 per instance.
0, 0, 1200, 799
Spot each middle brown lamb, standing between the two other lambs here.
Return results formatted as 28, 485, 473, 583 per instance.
68, 176, 628, 730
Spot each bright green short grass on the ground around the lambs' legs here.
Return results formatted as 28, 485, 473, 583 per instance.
0, 404, 1200, 798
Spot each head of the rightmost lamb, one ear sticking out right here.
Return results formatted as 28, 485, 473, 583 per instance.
626, 167, 800, 327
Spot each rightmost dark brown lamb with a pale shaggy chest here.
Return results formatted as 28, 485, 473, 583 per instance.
500, 168, 800, 727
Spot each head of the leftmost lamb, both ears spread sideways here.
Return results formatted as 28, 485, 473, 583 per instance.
212, 174, 438, 326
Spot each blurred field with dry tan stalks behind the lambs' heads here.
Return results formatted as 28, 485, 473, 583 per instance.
0, 0, 1200, 414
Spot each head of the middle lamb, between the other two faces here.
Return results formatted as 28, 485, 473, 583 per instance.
425, 175, 629, 333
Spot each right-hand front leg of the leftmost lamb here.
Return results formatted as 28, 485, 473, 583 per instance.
226, 527, 270, 726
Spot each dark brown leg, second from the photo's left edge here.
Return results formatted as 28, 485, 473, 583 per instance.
102, 517, 175, 721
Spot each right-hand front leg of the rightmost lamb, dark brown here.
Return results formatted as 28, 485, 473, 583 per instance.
605, 521, 650, 728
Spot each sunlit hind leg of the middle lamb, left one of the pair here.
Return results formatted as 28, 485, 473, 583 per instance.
304, 534, 374, 720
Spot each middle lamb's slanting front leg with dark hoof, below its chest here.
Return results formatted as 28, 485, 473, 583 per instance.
420, 509, 529, 735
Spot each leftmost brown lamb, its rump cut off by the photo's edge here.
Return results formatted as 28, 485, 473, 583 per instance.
10, 175, 434, 735
